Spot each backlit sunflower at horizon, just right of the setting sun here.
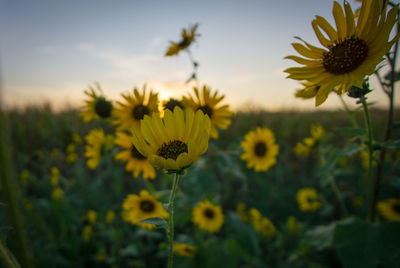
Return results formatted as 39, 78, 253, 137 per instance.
183, 86, 233, 139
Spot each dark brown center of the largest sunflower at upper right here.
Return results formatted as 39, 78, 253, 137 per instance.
323, 36, 368, 74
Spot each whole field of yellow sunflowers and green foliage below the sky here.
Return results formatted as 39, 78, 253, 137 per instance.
0, 0, 400, 268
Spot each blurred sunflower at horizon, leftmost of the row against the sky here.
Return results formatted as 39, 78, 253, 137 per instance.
81, 83, 113, 122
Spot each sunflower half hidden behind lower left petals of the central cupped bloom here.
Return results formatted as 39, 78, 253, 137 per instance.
115, 131, 156, 179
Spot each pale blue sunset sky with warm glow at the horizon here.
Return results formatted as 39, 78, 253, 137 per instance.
0, 0, 396, 111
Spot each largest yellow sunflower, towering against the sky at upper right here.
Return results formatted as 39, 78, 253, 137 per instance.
285, 0, 400, 106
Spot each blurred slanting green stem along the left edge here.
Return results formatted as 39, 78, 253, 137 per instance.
0, 112, 33, 268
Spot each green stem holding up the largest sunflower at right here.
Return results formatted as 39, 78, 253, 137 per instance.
360, 96, 373, 222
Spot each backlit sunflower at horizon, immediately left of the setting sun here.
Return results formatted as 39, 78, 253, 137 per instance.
113, 85, 158, 130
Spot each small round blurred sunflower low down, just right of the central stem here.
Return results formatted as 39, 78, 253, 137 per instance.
192, 200, 224, 233
